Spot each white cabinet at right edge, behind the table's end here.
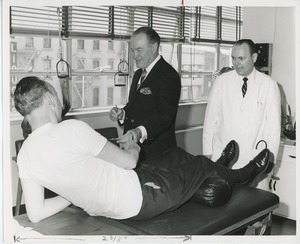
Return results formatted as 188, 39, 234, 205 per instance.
269, 139, 296, 220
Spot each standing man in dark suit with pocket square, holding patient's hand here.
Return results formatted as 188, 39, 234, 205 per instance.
110, 27, 181, 162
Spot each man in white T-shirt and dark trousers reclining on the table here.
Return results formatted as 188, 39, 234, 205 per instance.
14, 77, 273, 222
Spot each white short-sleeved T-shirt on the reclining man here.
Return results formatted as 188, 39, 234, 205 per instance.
18, 120, 142, 219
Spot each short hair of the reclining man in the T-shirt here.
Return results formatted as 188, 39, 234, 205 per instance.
14, 76, 56, 116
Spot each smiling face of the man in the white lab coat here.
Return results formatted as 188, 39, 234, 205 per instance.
231, 43, 257, 76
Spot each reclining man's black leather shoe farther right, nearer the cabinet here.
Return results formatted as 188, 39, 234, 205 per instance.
241, 148, 274, 185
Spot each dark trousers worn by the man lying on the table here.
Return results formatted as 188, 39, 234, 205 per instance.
132, 156, 217, 220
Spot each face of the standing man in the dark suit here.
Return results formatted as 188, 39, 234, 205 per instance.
130, 33, 158, 69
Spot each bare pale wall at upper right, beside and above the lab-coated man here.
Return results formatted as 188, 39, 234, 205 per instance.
243, 7, 296, 117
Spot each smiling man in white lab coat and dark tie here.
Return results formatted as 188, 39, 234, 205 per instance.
203, 39, 281, 188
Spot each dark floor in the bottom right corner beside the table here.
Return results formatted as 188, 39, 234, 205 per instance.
271, 215, 296, 235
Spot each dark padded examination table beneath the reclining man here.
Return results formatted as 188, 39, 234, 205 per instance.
15, 127, 279, 235
